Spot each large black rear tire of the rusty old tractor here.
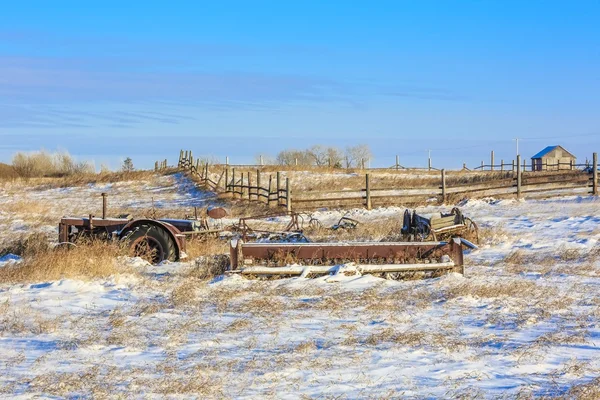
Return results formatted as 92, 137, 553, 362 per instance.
122, 224, 177, 264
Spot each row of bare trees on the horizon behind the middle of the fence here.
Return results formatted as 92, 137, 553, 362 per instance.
274, 144, 372, 168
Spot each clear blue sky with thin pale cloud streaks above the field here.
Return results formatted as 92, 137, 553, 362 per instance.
0, 1, 600, 168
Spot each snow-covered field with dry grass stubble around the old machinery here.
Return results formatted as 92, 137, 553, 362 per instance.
0, 178, 600, 399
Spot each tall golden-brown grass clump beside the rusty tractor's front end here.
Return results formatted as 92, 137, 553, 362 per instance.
0, 238, 131, 283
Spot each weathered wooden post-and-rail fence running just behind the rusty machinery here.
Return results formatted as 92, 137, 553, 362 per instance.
179, 150, 598, 211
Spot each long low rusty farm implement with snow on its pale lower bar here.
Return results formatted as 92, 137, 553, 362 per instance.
230, 238, 470, 279
